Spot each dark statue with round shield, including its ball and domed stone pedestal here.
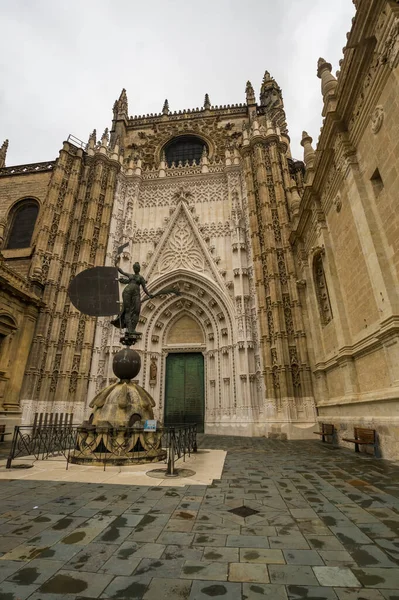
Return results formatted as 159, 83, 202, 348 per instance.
68, 239, 180, 465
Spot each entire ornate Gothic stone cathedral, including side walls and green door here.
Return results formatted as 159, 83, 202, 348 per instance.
0, 0, 399, 457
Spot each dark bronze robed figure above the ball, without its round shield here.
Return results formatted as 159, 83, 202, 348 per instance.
111, 262, 154, 337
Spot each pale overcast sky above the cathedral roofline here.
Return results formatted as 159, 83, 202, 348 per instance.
0, 0, 355, 166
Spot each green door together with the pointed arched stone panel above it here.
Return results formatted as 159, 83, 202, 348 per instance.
164, 314, 205, 432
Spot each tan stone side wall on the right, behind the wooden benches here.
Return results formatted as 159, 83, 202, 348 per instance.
299, 3, 399, 458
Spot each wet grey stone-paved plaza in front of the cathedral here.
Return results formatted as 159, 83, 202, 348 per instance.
0, 436, 399, 600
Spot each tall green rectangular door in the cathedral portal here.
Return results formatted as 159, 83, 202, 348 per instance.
164, 352, 205, 432
